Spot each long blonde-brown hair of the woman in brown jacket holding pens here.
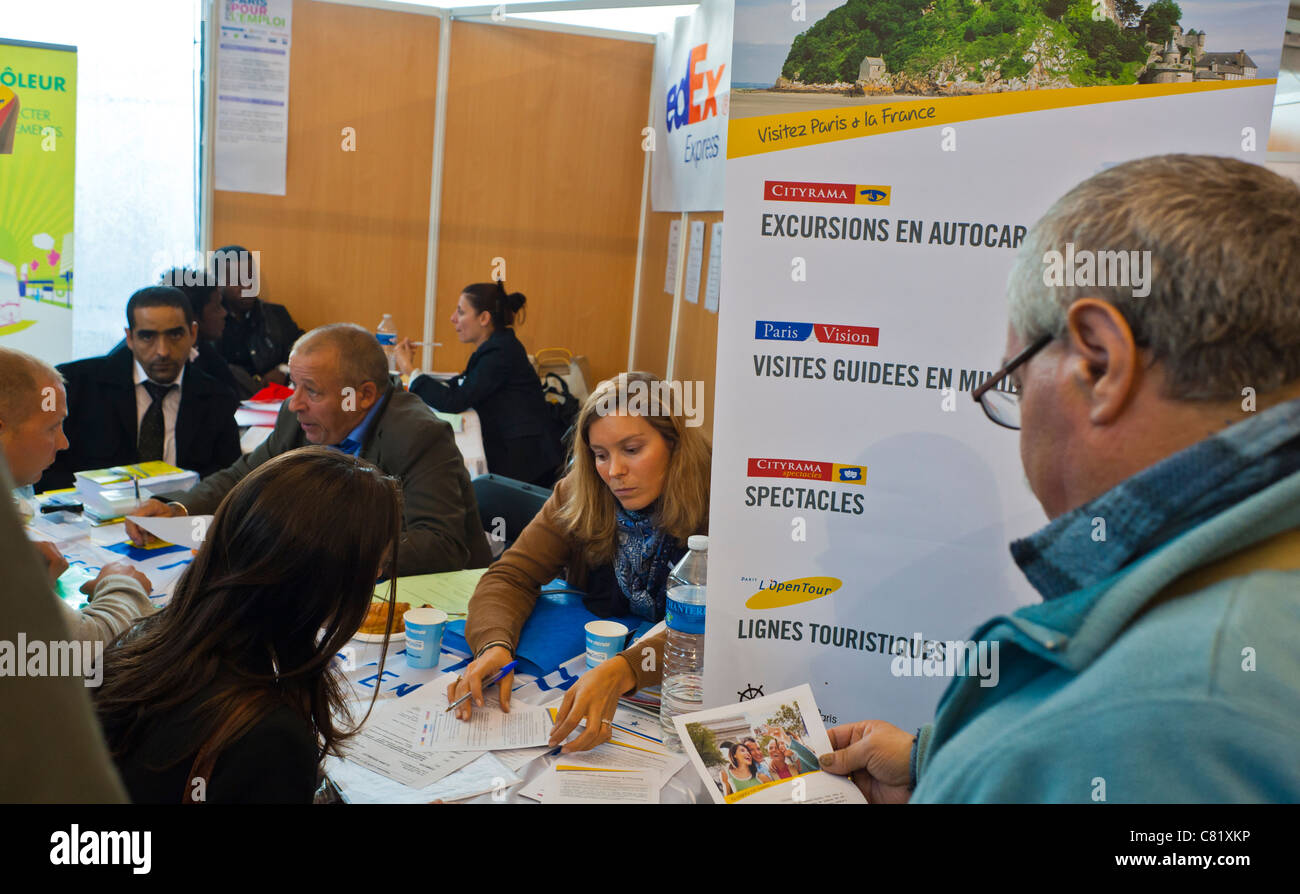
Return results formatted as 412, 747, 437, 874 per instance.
559, 372, 714, 564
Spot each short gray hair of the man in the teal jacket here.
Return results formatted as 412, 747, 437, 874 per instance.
1008, 155, 1300, 400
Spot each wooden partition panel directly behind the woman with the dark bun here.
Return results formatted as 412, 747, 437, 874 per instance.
434, 22, 654, 385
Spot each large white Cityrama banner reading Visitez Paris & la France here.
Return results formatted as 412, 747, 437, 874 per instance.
705, 0, 1287, 729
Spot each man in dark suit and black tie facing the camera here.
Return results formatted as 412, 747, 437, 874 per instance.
38, 286, 239, 490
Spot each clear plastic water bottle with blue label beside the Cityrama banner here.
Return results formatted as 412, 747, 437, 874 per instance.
659, 534, 709, 751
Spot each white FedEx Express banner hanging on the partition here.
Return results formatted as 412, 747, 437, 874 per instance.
647, 0, 733, 212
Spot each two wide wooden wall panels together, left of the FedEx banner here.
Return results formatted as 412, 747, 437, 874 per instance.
213, 3, 654, 387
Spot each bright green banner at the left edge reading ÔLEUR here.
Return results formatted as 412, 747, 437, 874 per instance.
0, 40, 77, 363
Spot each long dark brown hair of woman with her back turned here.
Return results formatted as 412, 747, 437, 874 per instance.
95, 447, 402, 779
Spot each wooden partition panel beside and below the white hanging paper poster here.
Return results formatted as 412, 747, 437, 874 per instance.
212, 3, 438, 338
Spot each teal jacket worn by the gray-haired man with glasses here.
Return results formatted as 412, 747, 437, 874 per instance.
911, 473, 1300, 803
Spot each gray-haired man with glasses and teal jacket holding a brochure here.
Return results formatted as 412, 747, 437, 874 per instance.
822, 156, 1300, 802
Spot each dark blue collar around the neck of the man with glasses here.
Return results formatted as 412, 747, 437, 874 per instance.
1011, 400, 1300, 600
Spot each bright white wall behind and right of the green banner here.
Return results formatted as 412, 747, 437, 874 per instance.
0, 0, 202, 360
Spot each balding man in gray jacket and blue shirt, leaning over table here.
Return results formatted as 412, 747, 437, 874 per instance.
126, 322, 491, 574
